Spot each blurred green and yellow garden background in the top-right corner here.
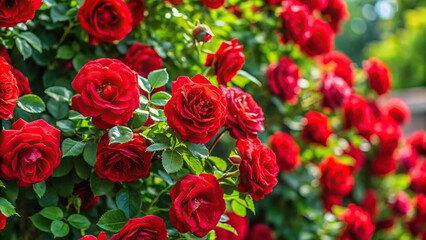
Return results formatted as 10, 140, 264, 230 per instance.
336, 0, 426, 134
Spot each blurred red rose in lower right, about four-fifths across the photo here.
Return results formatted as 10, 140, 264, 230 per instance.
319, 156, 354, 196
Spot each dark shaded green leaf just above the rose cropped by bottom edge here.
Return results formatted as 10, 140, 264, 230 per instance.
115, 188, 142, 218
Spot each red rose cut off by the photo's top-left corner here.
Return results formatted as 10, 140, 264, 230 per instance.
0, 0, 41, 28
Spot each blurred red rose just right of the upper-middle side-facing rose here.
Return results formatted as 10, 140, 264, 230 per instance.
266, 57, 301, 105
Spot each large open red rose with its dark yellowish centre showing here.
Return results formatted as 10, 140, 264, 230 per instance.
71, 58, 139, 129
